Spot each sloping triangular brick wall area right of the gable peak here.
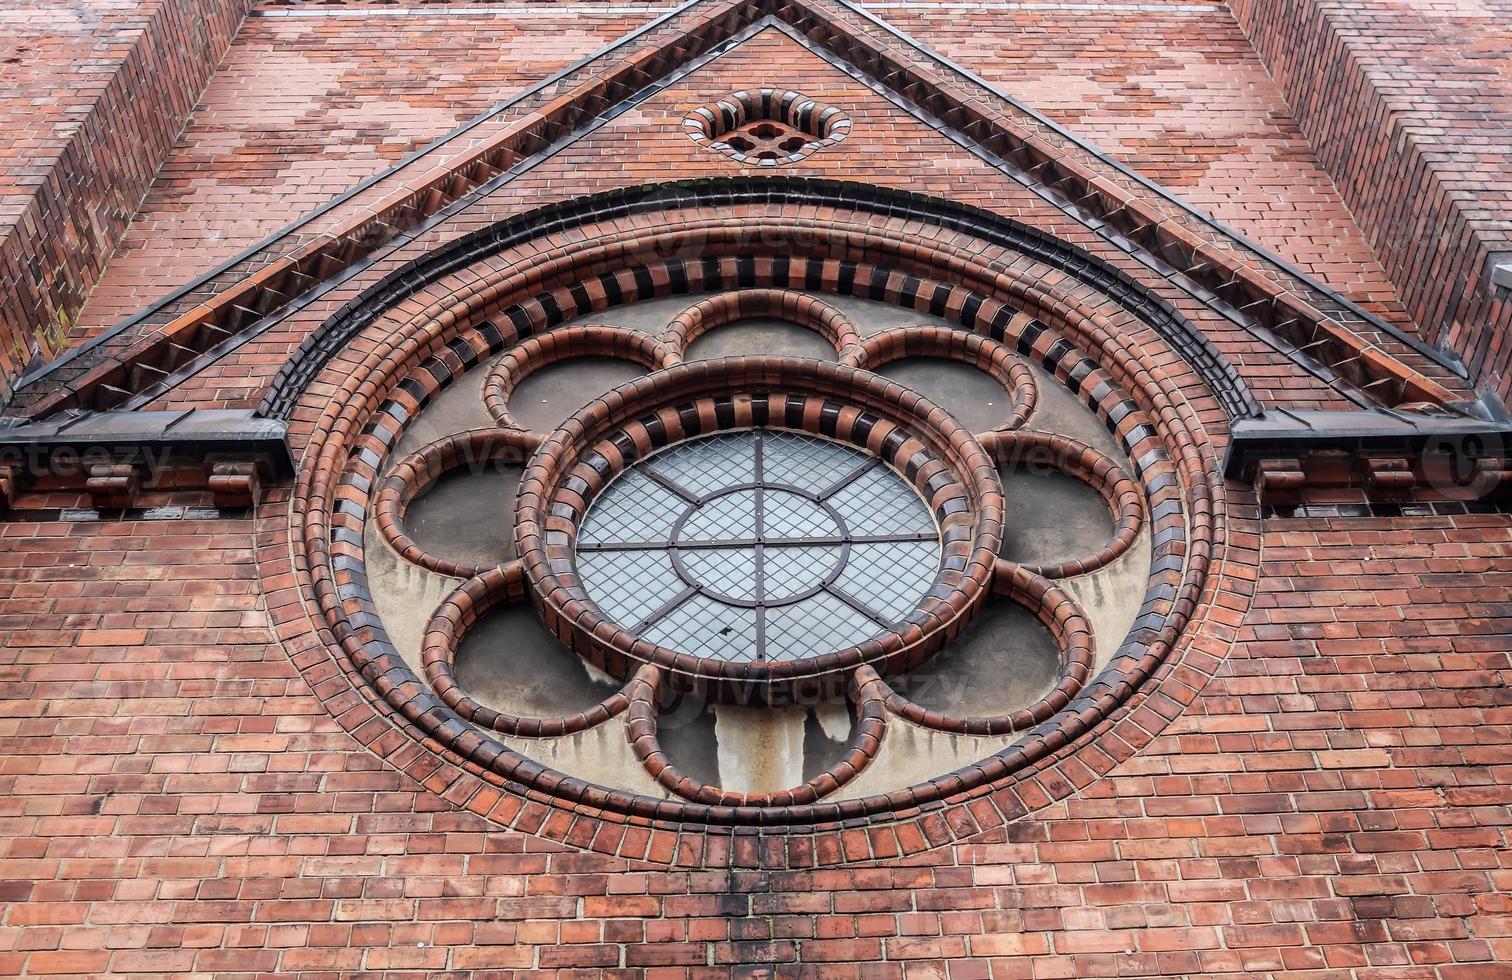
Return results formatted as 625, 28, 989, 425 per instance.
877, 3, 1412, 330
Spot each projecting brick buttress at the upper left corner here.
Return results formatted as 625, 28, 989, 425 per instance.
0, 0, 248, 401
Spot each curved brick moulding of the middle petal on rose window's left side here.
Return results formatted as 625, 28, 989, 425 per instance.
373, 430, 526, 578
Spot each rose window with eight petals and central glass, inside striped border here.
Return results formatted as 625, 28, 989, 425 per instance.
347, 289, 1161, 823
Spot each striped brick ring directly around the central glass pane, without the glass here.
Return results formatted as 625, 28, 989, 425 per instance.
516, 357, 1002, 702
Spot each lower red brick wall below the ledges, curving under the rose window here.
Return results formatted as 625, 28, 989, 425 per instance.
0, 505, 1512, 980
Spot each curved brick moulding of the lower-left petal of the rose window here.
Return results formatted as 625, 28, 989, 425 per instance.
420, 561, 631, 738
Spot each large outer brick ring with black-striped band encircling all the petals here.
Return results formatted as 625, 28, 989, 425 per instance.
260, 181, 1256, 867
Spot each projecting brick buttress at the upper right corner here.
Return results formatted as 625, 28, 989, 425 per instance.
1231, 0, 1512, 396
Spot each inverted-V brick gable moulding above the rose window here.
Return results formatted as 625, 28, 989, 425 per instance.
15, 0, 1464, 416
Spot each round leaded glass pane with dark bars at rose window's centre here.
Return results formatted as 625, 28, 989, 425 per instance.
576, 430, 940, 662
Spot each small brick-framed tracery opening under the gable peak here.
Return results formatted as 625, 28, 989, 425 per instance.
682, 88, 851, 166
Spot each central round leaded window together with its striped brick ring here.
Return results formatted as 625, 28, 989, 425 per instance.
516, 357, 1002, 703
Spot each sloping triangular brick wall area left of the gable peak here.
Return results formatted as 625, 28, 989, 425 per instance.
71, 5, 652, 340
